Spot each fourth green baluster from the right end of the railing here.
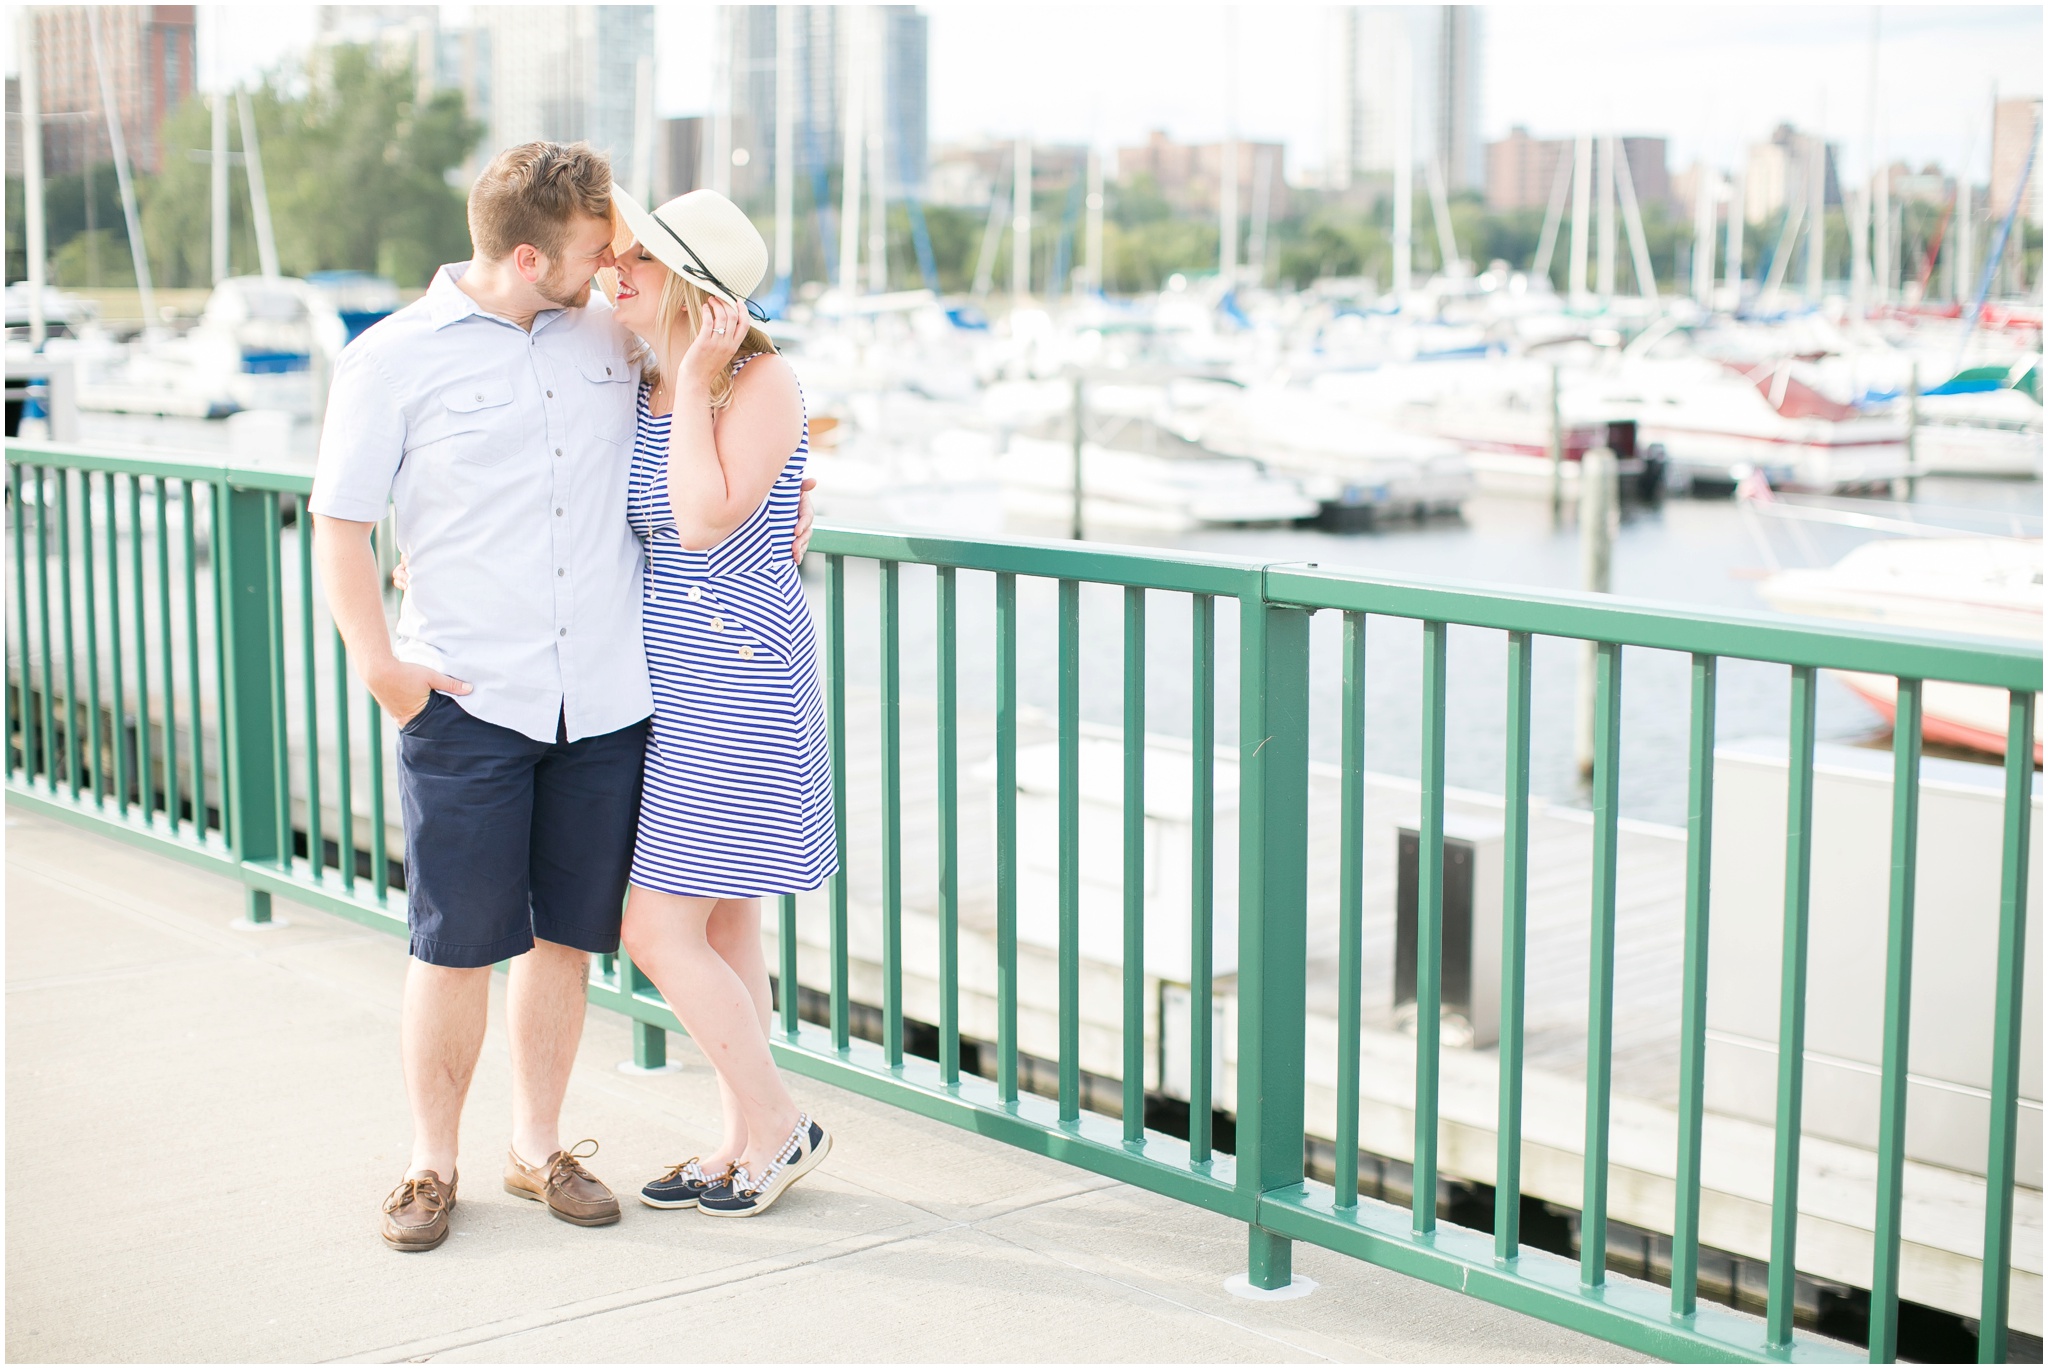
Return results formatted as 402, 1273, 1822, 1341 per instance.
1671, 654, 1720, 1316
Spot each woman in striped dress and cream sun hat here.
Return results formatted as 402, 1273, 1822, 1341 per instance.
608, 186, 838, 1217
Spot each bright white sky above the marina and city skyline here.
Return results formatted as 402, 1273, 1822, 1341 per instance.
6, 0, 2042, 178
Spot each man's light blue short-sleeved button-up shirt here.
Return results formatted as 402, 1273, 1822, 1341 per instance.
311, 262, 653, 742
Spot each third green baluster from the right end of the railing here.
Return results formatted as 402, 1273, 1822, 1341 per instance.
1765, 666, 1817, 1346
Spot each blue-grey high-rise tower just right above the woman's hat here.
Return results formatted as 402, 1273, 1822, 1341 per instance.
719, 4, 930, 207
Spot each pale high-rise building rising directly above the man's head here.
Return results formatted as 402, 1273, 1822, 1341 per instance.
468, 4, 655, 184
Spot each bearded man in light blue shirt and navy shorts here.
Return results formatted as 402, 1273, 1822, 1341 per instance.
311, 143, 809, 1250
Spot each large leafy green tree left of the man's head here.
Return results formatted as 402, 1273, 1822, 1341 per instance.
143, 47, 483, 287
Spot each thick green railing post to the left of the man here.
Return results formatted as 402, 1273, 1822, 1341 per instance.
219, 486, 289, 924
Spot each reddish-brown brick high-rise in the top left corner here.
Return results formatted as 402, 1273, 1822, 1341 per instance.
35, 4, 197, 176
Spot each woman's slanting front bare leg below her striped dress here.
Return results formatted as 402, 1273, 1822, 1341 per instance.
621, 887, 797, 1174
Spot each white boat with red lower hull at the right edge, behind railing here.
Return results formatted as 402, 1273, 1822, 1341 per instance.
1761, 537, 2048, 760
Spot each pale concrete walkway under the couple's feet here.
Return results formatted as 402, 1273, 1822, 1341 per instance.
6, 814, 1646, 1361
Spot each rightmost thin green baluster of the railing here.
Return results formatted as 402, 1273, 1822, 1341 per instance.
1976, 691, 2038, 1363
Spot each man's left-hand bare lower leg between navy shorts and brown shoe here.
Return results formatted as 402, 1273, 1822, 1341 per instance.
399, 959, 492, 1180
